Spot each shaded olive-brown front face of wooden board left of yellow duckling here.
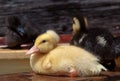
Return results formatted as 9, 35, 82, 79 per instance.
0, 59, 31, 74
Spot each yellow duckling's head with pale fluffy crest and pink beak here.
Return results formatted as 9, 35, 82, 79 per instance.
26, 30, 60, 54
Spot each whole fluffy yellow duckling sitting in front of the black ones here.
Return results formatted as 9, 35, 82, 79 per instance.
26, 30, 107, 77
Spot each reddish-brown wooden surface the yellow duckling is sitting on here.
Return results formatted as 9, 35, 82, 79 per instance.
0, 72, 120, 81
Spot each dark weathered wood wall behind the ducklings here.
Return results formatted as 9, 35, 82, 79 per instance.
0, 0, 120, 36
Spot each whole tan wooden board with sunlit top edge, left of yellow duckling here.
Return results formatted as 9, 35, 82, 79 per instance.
0, 49, 31, 74
